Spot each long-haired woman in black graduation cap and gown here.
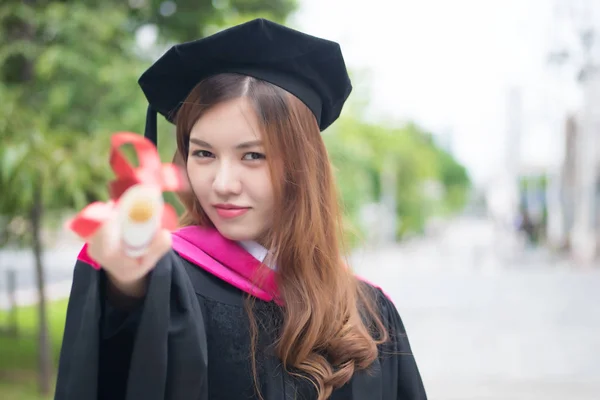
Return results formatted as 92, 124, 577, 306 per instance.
56, 19, 426, 400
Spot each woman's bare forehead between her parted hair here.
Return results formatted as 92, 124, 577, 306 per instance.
190, 97, 262, 143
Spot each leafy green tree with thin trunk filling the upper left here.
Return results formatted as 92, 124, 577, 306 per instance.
0, 0, 295, 394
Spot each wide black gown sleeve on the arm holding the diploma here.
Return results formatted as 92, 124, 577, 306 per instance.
55, 251, 208, 400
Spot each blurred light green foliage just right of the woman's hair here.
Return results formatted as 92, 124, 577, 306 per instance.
324, 115, 470, 238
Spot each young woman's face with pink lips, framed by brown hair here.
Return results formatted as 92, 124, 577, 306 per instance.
187, 98, 274, 241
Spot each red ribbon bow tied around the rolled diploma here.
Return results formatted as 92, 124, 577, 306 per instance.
66, 132, 188, 239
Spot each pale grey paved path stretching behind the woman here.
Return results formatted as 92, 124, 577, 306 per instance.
0, 220, 600, 400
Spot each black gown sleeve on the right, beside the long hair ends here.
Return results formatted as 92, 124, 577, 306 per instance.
377, 289, 427, 400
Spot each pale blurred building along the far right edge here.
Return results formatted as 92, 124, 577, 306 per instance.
528, 0, 600, 262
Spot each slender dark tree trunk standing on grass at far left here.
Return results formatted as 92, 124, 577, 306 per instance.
30, 180, 52, 395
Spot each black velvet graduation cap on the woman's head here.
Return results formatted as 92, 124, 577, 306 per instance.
138, 18, 352, 144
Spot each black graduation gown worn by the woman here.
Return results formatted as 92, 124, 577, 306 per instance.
55, 251, 426, 400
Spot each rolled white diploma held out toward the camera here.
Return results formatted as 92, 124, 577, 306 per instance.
117, 184, 164, 257
